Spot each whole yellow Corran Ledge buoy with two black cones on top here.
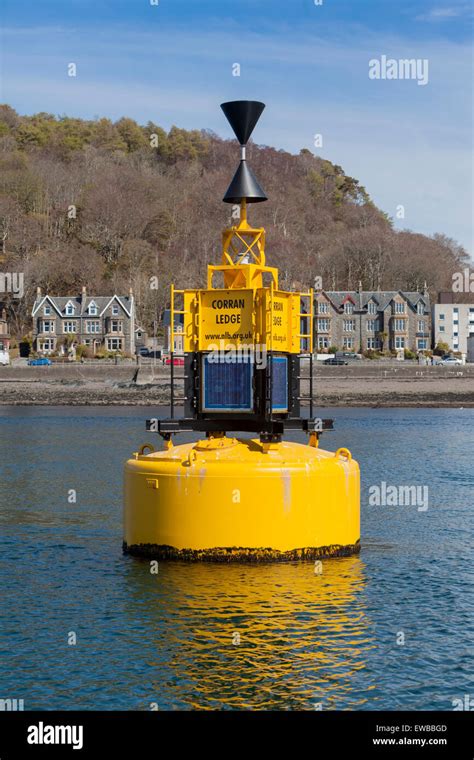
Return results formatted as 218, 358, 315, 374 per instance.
124, 101, 360, 561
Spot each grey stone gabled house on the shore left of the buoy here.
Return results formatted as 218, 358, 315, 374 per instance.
32, 288, 135, 354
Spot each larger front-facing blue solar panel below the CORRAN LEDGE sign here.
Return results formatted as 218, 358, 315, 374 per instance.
202, 356, 253, 412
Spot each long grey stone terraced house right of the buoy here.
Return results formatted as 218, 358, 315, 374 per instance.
314, 287, 431, 352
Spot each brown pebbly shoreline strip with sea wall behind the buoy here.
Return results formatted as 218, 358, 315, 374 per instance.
0, 362, 474, 406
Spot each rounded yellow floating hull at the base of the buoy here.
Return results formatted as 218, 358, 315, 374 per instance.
124, 438, 360, 562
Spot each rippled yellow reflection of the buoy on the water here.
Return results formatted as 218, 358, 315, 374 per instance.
128, 558, 374, 709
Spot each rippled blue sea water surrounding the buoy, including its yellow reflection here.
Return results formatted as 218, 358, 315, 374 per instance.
0, 408, 474, 710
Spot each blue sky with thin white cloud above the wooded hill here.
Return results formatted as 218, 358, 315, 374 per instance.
1, 0, 473, 252
